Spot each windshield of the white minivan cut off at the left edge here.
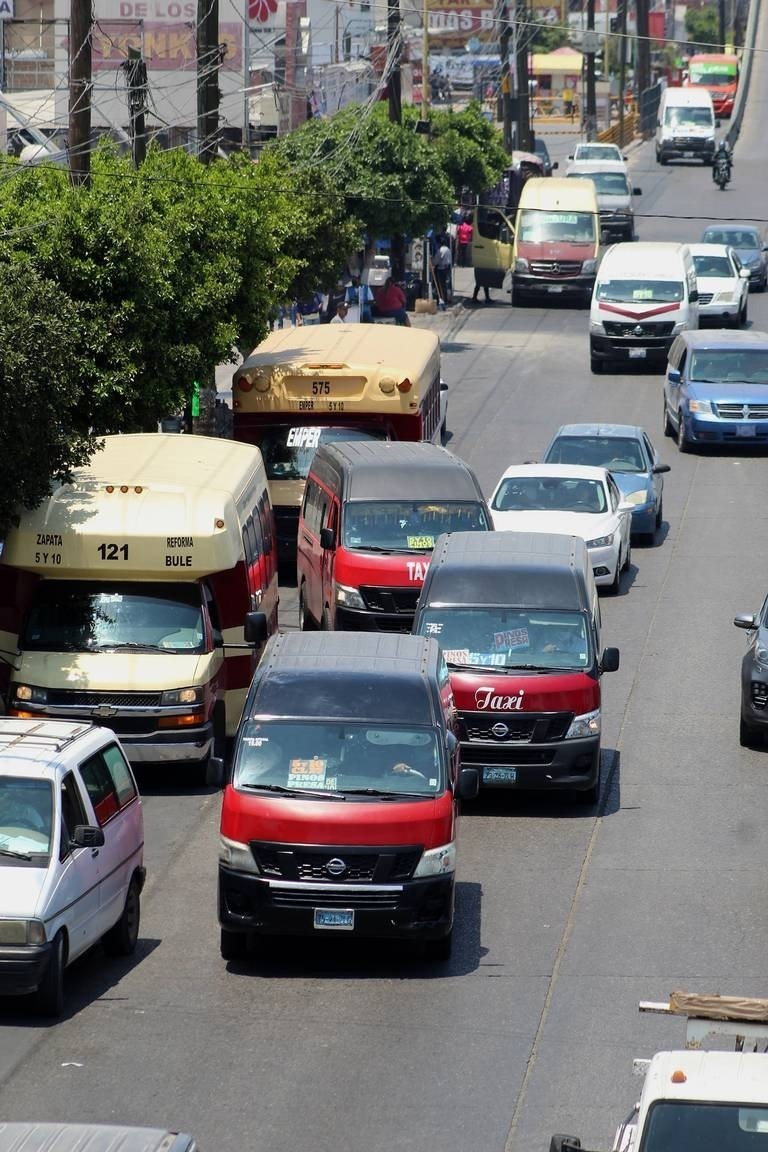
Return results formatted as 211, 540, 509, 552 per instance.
0, 775, 53, 866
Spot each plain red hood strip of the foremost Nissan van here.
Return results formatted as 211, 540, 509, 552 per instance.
221, 785, 454, 848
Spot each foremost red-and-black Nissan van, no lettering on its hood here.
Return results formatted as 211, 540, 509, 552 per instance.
219, 632, 479, 960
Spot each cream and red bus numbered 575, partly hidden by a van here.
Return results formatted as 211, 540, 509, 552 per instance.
233, 324, 447, 560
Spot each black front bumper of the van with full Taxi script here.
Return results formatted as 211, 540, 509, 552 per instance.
462, 736, 600, 791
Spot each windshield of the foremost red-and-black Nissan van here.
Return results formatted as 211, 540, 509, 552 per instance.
233, 720, 446, 796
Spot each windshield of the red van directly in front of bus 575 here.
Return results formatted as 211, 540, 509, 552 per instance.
343, 500, 488, 552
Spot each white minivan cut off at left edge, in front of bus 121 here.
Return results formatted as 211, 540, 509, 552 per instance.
0, 718, 145, 1016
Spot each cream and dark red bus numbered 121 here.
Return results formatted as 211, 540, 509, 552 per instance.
0, 433, 277, 782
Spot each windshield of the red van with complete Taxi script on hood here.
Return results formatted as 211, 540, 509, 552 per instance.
418, 605, 592, 669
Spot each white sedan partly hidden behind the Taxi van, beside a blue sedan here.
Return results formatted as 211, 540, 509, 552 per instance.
489, 464, 632, 592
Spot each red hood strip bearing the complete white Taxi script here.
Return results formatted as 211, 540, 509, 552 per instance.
450, 668, 600, 715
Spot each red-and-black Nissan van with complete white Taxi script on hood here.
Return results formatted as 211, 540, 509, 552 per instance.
413, 532, 618, 804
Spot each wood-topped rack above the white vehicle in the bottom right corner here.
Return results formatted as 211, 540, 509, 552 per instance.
639, 992, 768, 1052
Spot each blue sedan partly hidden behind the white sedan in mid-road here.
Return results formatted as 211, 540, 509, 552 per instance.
541, 424, 669, 543
